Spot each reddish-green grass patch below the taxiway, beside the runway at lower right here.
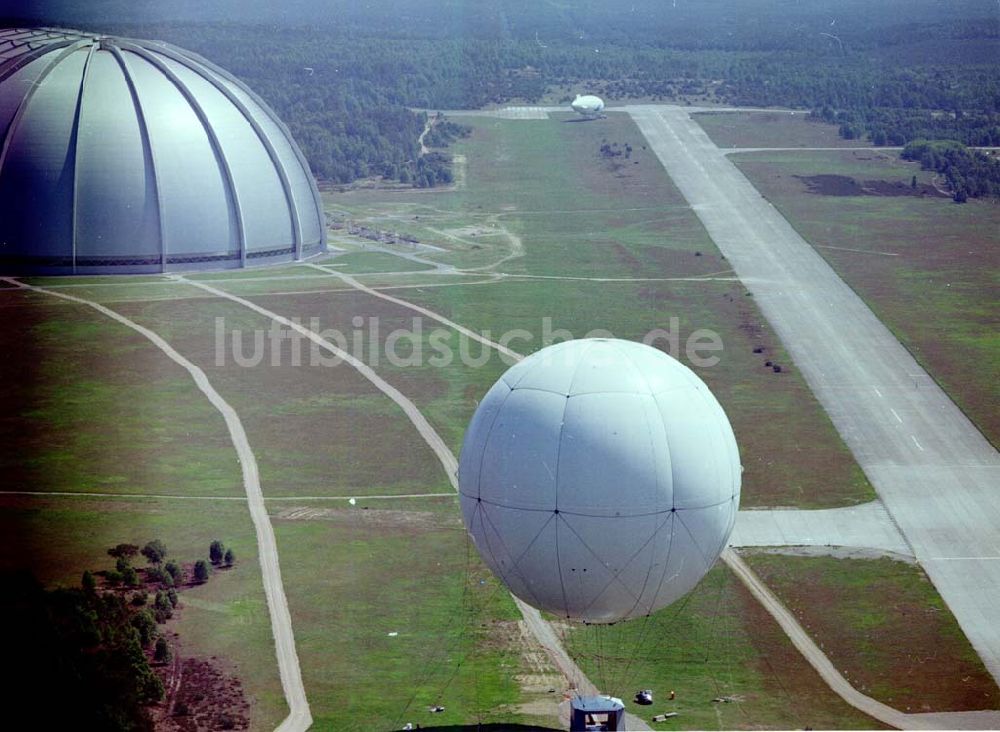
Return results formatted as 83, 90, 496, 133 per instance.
746, 553, 1000, 713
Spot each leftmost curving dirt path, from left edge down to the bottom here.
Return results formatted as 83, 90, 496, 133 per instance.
0, 277, 312, 732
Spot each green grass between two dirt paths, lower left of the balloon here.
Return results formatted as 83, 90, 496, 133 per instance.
272, 499, 554, 730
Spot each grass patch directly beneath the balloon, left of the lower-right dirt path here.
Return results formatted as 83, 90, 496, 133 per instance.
563, 565, 880, 730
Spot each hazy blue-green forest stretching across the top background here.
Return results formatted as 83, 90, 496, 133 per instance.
15, 0, 1000, 185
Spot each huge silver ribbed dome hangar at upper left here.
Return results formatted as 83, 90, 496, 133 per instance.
0, 28, 326, 274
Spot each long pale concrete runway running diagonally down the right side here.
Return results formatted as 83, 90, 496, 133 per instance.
626, 105, 1000, 681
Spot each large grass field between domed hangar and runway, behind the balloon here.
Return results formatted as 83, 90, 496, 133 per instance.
326, 114, 874, 507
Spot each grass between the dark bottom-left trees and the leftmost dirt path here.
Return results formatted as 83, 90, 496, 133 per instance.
0, 496, 287, 730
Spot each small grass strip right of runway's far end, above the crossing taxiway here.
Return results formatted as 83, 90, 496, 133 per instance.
692, 111, 871, 148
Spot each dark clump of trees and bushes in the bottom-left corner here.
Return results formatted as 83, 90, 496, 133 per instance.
0, 539, 236, 732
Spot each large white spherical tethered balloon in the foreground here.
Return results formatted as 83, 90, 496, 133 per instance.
458, 339, 741, 623
